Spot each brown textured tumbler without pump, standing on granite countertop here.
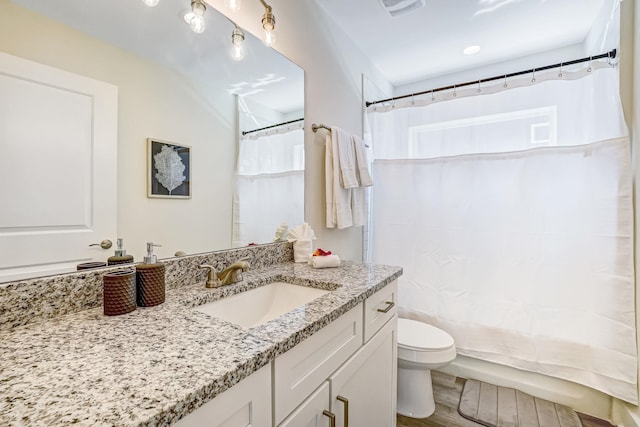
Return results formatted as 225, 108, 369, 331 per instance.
102, 270, 136, 316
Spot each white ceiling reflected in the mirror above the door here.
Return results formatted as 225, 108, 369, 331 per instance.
11, 0, 304, 113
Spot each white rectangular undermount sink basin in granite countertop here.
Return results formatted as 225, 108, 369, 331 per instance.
194, 282, 331, 328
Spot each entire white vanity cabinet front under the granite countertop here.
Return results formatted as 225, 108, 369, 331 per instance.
175, 282, 398, 427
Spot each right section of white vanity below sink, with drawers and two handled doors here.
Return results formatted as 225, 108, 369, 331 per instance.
273, 282, 398, 427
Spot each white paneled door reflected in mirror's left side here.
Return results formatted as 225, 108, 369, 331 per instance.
0, 52, 118, 282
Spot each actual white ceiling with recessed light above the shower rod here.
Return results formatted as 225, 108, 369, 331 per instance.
316, 0, 610, 86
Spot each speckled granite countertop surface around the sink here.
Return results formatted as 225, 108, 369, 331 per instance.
0, 262, 402, 426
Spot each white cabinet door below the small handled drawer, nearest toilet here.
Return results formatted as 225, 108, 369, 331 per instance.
330, 315, 398, 427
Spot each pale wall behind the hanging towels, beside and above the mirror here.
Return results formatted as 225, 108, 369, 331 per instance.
208, 0, 389, 260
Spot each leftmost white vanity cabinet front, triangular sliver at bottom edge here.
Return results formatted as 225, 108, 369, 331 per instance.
175, 365, 271, 427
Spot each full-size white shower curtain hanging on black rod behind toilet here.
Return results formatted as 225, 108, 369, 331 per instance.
369, 65, 638, 403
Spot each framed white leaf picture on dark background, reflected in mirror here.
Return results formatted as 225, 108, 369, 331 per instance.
147, 138, 191, 199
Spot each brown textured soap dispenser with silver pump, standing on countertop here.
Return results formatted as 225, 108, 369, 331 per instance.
136, 243, 165, 307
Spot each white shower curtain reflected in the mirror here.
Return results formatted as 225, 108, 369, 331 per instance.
233, 129, 304, 247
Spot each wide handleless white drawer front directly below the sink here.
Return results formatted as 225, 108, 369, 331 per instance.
273, 304, 363, 425
